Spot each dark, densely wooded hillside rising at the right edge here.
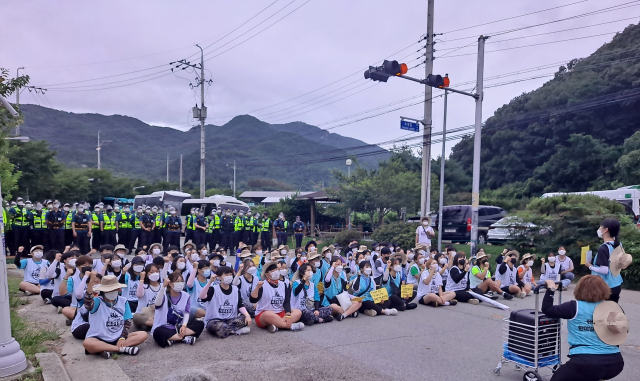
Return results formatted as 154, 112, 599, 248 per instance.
445, 25, 640, 196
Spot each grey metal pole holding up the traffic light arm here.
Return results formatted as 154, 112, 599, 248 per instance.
471, 36, 488, 257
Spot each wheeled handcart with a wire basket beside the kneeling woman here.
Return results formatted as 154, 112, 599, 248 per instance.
493, 282, 562, 381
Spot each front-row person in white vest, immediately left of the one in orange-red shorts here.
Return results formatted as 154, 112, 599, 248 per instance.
199, 266, 251, 339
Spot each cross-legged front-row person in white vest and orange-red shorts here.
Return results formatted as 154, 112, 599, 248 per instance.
249, 261, 304, 333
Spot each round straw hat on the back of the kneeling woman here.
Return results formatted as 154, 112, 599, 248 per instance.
593, 300, 629, 345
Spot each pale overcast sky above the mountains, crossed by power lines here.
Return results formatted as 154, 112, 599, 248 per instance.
0, 0, 640, 161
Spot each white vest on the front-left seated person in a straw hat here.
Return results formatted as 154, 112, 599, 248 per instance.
87, 296, 127, 342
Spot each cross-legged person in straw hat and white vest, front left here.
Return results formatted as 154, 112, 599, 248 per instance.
82, 271, 147, 359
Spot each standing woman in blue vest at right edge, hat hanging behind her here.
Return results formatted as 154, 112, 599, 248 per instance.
585, 218, 631, 303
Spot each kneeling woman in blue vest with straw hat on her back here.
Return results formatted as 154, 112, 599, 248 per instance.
541, 275, 629, 381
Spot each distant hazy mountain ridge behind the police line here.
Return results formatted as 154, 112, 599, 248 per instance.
20, 105, 390, 190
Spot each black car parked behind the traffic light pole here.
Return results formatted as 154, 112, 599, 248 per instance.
436, 205, 507, 245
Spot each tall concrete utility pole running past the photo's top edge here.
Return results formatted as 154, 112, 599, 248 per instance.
420, 0, 434, 217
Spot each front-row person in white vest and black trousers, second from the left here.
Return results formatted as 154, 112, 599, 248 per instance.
151, 272, 204, 348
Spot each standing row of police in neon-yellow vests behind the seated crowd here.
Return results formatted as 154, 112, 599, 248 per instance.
2, 197, 305, 254
